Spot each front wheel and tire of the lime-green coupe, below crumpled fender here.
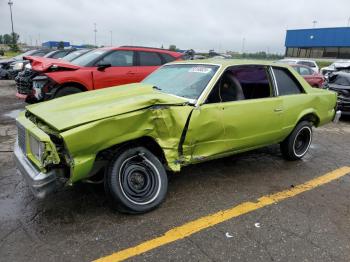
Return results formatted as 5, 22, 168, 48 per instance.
105, 147, 168, 214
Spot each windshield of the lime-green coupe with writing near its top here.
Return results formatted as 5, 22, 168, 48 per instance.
142, 64, 219, 99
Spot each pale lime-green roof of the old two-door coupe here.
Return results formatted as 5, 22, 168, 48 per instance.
169, 59, 289, 68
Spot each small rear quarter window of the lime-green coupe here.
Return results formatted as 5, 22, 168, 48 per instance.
273, 67, 303, 96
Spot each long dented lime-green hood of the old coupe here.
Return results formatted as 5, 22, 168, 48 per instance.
26, 83, 188, 131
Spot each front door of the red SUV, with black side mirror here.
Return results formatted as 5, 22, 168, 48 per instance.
92, 50, 139, 89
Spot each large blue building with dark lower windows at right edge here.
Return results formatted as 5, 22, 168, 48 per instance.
285, 27, 350, 58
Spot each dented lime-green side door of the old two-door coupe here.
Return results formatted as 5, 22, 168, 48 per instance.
185, 67, 283, 160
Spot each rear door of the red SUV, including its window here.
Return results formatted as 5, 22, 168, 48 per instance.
137, 51, 164, 81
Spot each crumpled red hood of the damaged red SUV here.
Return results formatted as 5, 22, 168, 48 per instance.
24, 56, 80, 72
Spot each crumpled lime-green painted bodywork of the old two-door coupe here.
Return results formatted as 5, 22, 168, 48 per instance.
13, 61, 336, 194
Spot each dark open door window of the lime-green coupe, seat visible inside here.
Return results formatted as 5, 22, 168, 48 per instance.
207, 66, 274, 103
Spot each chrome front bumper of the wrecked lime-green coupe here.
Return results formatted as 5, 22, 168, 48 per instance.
14, 142, 64, 198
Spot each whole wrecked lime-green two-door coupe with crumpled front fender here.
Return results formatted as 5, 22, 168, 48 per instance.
14, 59, 338, 213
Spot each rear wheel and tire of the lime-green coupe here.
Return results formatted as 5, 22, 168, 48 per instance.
280, 121, 312, 160
